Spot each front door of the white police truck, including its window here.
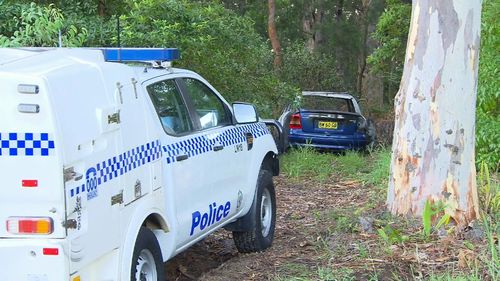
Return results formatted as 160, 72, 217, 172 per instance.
181, 77, 253, 215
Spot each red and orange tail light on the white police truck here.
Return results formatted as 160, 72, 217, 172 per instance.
7, 217, 54, 235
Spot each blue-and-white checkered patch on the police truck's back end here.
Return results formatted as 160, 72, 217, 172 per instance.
0, 133, 55, 156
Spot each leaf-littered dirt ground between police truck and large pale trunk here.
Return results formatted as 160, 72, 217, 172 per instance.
166, 176, 487, 281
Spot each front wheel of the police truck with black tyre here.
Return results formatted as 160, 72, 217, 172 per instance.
233, 170, 276, 253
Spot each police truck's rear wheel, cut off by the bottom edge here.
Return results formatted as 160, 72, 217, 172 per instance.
130, 227, 165, 281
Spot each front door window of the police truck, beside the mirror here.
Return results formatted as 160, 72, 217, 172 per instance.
184, 78, 231, 129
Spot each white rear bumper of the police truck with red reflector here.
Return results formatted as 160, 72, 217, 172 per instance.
0, 238, 70, 281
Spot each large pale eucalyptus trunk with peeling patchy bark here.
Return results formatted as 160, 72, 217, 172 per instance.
387, 0, 481, 225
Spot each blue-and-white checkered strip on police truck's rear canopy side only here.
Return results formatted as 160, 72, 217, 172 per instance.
70, 140, 161, 197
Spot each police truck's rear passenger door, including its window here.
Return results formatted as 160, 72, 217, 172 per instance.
146, 78, 235, 249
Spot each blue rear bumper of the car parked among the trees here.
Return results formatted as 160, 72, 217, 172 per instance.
289, 131, 369, 150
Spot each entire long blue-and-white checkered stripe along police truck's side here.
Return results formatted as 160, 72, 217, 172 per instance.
70, 123, 269, 197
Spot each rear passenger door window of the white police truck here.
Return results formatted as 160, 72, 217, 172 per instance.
147, 80, 193, 135
